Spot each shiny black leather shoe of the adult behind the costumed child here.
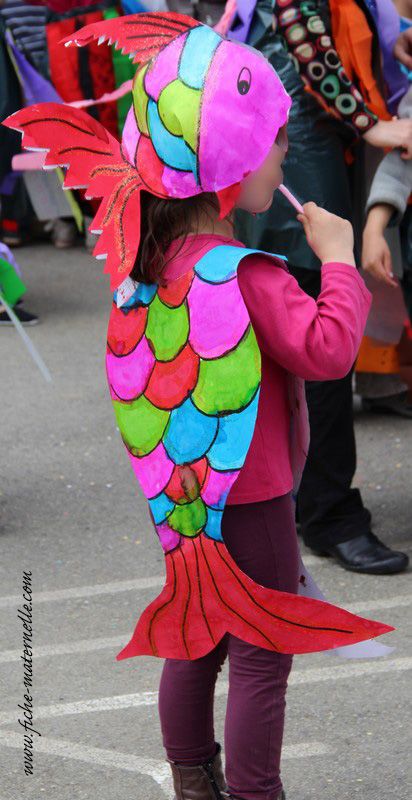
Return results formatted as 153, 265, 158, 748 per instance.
312, 532, 409, 575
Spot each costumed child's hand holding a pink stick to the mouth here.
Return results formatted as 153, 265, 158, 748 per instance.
298, 203, 356, 267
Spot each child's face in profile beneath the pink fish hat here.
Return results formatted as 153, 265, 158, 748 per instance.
236, 125, 288, 214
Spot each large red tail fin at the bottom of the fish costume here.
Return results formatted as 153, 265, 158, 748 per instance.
116, 535, 393, 661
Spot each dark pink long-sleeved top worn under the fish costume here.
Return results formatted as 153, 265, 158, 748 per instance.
164, 234, 371, 504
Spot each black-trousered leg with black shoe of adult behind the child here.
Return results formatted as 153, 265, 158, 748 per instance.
291, 267, 409, 575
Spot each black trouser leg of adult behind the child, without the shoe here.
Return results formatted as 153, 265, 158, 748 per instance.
290, 267, 370, 550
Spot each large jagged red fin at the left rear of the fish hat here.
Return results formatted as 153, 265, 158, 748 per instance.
3, 103, 141, 290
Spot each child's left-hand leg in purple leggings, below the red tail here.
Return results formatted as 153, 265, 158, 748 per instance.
159, 637, 227, 766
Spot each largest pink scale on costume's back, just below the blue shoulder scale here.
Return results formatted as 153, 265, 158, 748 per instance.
188, 276, 249, 358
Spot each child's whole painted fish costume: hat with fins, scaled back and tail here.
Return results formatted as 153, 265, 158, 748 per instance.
5, 13, 393, 660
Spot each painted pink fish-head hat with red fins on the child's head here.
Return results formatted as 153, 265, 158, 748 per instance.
4, 12, 291, 289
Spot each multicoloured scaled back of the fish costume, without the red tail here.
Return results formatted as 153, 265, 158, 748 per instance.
106, 245, 261, 552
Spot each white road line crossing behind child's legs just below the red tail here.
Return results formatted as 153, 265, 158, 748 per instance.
0, 657, 412, 725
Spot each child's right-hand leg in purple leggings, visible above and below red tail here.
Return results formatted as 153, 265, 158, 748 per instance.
222, 495, 299, 800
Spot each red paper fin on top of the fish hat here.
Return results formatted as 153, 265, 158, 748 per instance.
62, 11, 201, 64
